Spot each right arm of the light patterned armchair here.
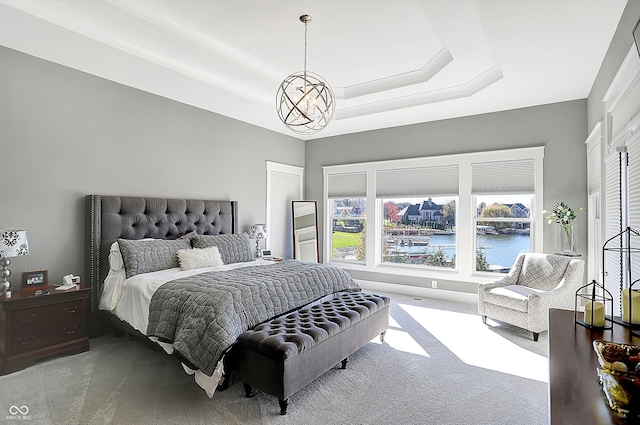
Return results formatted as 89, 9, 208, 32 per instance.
527, 259, 584, 332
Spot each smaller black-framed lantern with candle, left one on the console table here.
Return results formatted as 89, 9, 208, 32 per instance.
574, 280, 613, 329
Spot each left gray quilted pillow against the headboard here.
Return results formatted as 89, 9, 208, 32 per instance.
118, 235, 191, 279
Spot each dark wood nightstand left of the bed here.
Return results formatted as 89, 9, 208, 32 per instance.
0, 284, 91, 375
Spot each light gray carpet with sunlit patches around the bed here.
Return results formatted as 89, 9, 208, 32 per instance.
0, 295, 548, 425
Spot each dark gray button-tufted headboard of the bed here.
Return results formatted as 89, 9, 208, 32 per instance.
85, 195, 238, 328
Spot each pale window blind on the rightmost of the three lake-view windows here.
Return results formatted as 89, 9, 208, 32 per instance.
471, 159, 535, 195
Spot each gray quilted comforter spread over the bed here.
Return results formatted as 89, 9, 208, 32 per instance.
147, 261, 360, 375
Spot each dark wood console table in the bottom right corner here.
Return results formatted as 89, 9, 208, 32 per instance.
549, 309, 640, 425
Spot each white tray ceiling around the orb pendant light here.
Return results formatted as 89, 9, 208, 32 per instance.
0, 0, 633, 139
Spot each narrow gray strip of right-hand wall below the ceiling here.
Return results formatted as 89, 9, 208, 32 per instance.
587, 0, 640, 131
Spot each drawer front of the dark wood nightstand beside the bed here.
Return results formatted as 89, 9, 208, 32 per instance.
6, 300, 86, 355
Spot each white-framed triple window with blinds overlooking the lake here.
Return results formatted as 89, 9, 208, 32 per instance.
323, 147, 544, 282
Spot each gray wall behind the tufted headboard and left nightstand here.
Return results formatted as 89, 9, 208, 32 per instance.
0, 47, 305, 290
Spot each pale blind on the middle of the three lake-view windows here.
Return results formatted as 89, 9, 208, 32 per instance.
376, 164, 459, 198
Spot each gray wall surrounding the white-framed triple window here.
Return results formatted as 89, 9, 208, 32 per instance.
305, 99, 587, 291
